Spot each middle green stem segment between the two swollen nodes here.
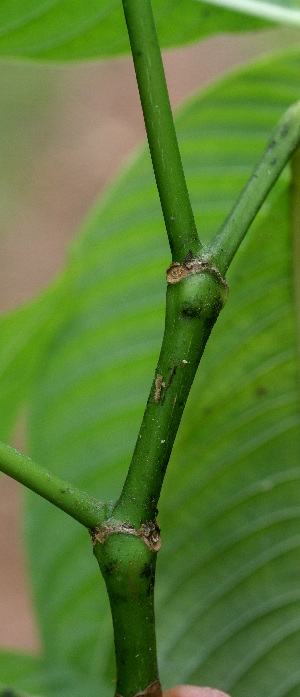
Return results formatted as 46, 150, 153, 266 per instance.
114, 271, 227, 526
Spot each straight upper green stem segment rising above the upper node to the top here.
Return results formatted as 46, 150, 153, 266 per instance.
123, 0, 201, 261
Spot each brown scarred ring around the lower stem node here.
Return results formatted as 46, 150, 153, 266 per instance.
89, 520, 161, 552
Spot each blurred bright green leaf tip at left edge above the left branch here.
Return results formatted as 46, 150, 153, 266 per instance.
0, 278, 67, 441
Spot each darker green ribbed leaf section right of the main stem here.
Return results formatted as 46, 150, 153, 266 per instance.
158, 194, 300, 697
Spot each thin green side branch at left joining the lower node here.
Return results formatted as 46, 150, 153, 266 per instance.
0, 442, 104, 528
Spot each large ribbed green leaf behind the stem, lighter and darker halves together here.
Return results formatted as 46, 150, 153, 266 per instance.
27, 47, 300, 697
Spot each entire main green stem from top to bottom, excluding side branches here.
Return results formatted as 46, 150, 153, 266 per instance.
101, 0, 227, 697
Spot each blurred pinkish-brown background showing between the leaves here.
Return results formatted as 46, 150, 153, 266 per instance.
0, 23, 297, 651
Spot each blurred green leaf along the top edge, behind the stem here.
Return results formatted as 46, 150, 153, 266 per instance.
0, 0, 265, 61
